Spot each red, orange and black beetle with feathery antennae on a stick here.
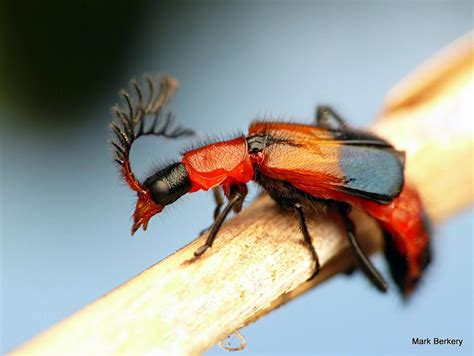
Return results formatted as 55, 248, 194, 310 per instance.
111, 77, 430, 296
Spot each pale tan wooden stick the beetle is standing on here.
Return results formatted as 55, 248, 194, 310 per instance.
13, 35, 474, 355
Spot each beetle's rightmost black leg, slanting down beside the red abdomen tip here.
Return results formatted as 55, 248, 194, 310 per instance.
338, 204, 388, 292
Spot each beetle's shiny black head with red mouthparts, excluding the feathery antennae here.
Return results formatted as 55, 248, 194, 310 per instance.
132, 163, 191, 235
